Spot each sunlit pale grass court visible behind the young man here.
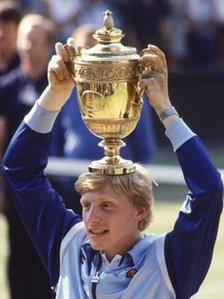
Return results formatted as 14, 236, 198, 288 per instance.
0, 191, 224, 299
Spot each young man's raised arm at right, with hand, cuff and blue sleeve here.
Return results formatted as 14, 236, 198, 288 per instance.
142, 46, 223, 299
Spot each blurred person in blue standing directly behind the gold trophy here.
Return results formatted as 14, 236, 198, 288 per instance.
51, 25, 155, 214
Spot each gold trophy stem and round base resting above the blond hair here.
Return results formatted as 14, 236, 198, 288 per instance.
89, 139, 135, 175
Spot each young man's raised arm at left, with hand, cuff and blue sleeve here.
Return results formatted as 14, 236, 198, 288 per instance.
2, 41, 81, 285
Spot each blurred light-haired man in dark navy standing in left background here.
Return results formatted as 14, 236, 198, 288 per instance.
0, 14, 55, 299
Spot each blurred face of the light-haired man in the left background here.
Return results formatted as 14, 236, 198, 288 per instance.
17, 26, 50, 68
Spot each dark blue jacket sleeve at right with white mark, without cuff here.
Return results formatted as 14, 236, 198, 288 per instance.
165, 136, 223, 299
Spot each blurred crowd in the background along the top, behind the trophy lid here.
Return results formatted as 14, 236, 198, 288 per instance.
2, 0, 224, 70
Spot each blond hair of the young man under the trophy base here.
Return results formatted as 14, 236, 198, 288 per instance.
75, 164, 154, 231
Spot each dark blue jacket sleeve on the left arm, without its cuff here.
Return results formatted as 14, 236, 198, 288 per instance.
2, 123, 81, 286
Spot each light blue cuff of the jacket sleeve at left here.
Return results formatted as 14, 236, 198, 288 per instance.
24, 102, 59, 133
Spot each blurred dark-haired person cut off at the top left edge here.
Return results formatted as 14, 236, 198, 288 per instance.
0, 1, 22, 76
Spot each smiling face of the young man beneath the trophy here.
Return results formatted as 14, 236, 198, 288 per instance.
81, 190, 145, 260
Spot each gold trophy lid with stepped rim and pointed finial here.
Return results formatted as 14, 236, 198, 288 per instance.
80, 10, 139, 61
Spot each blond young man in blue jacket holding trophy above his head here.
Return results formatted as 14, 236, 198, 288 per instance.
3, 44, 223, 299
